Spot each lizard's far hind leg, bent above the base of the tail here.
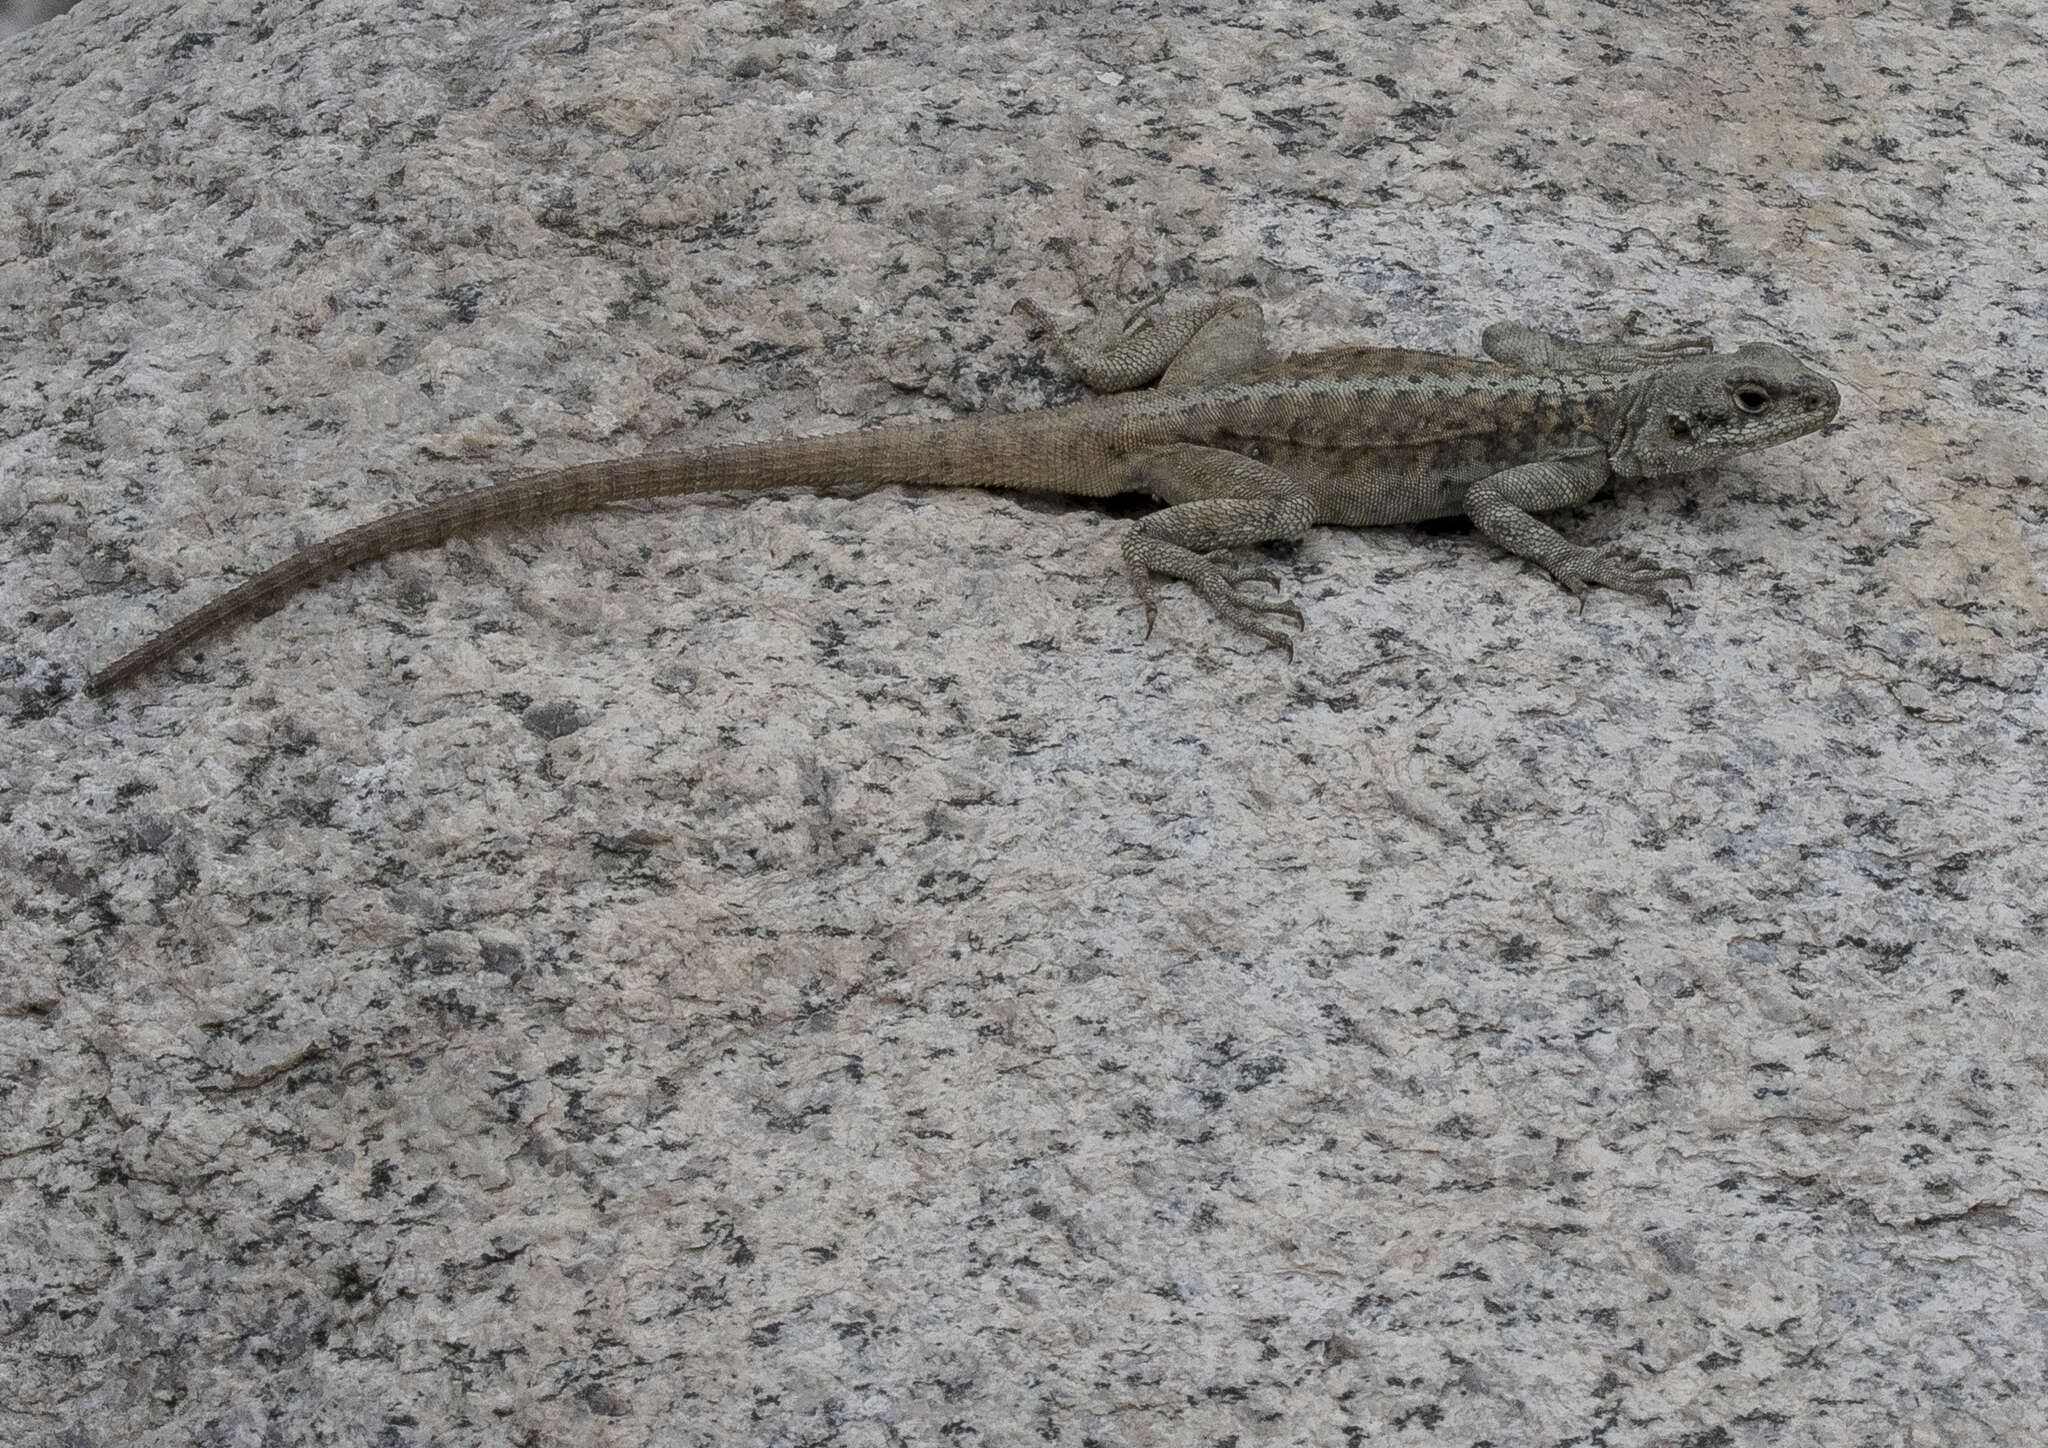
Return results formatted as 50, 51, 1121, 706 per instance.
1018, 246, 1266, 391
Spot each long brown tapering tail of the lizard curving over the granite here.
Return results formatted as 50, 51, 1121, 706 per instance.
86, 414, 1089, 694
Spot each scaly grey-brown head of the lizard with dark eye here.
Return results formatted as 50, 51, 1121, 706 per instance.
1614, 342, 1841, 475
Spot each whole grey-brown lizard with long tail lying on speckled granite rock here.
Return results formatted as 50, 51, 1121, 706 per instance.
86, 256, 1841, 694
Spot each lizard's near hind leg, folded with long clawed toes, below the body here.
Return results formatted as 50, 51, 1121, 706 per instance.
1124, 446, 1315, 655
